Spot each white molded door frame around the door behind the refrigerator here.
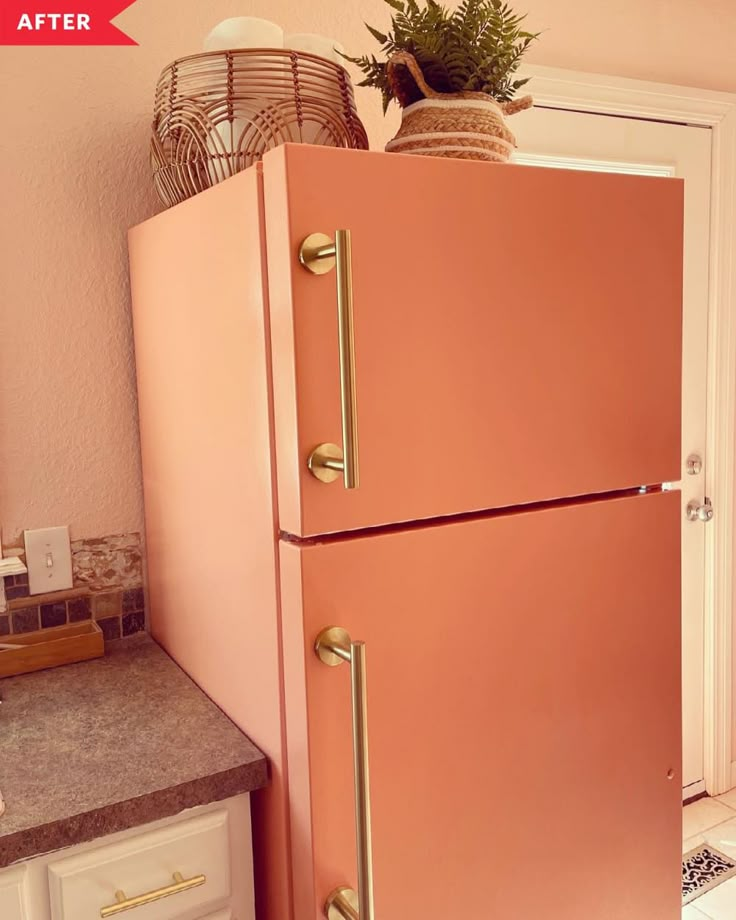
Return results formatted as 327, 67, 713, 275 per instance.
523, 66, 736, 795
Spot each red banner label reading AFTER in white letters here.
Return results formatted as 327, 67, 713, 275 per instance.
0, 0, 138, 45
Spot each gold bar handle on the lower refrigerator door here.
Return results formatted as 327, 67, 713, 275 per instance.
314, 626, 374, 920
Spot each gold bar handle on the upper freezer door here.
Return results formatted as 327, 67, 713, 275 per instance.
299, 230, 360, 489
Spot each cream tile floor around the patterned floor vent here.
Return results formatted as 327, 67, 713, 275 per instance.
682, 789, 736, 920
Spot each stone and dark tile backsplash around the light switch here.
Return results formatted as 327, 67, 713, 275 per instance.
0, 533, 146, 639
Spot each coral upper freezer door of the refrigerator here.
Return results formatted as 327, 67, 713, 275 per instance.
263, 145, 682, 535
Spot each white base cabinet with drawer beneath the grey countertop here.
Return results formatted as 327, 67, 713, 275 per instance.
0, 795, 255, 920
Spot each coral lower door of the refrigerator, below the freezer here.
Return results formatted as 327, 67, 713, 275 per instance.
281, 493, 681, 920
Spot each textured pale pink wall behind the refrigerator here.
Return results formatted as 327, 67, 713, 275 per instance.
0, 0, 736, 540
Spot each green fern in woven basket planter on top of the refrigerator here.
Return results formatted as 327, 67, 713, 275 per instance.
345, 0, 538, 162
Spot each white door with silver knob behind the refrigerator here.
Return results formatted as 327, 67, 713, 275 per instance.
512, 108, 711, 794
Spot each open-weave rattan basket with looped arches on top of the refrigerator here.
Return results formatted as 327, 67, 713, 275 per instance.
151, 48, 368, 206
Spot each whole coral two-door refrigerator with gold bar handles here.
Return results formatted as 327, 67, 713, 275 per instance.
129, 145, 683, 920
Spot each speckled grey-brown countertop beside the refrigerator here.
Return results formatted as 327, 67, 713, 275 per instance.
0, 636, 268, 867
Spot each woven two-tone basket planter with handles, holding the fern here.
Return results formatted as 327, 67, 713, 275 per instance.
386, 51, 532, 163
